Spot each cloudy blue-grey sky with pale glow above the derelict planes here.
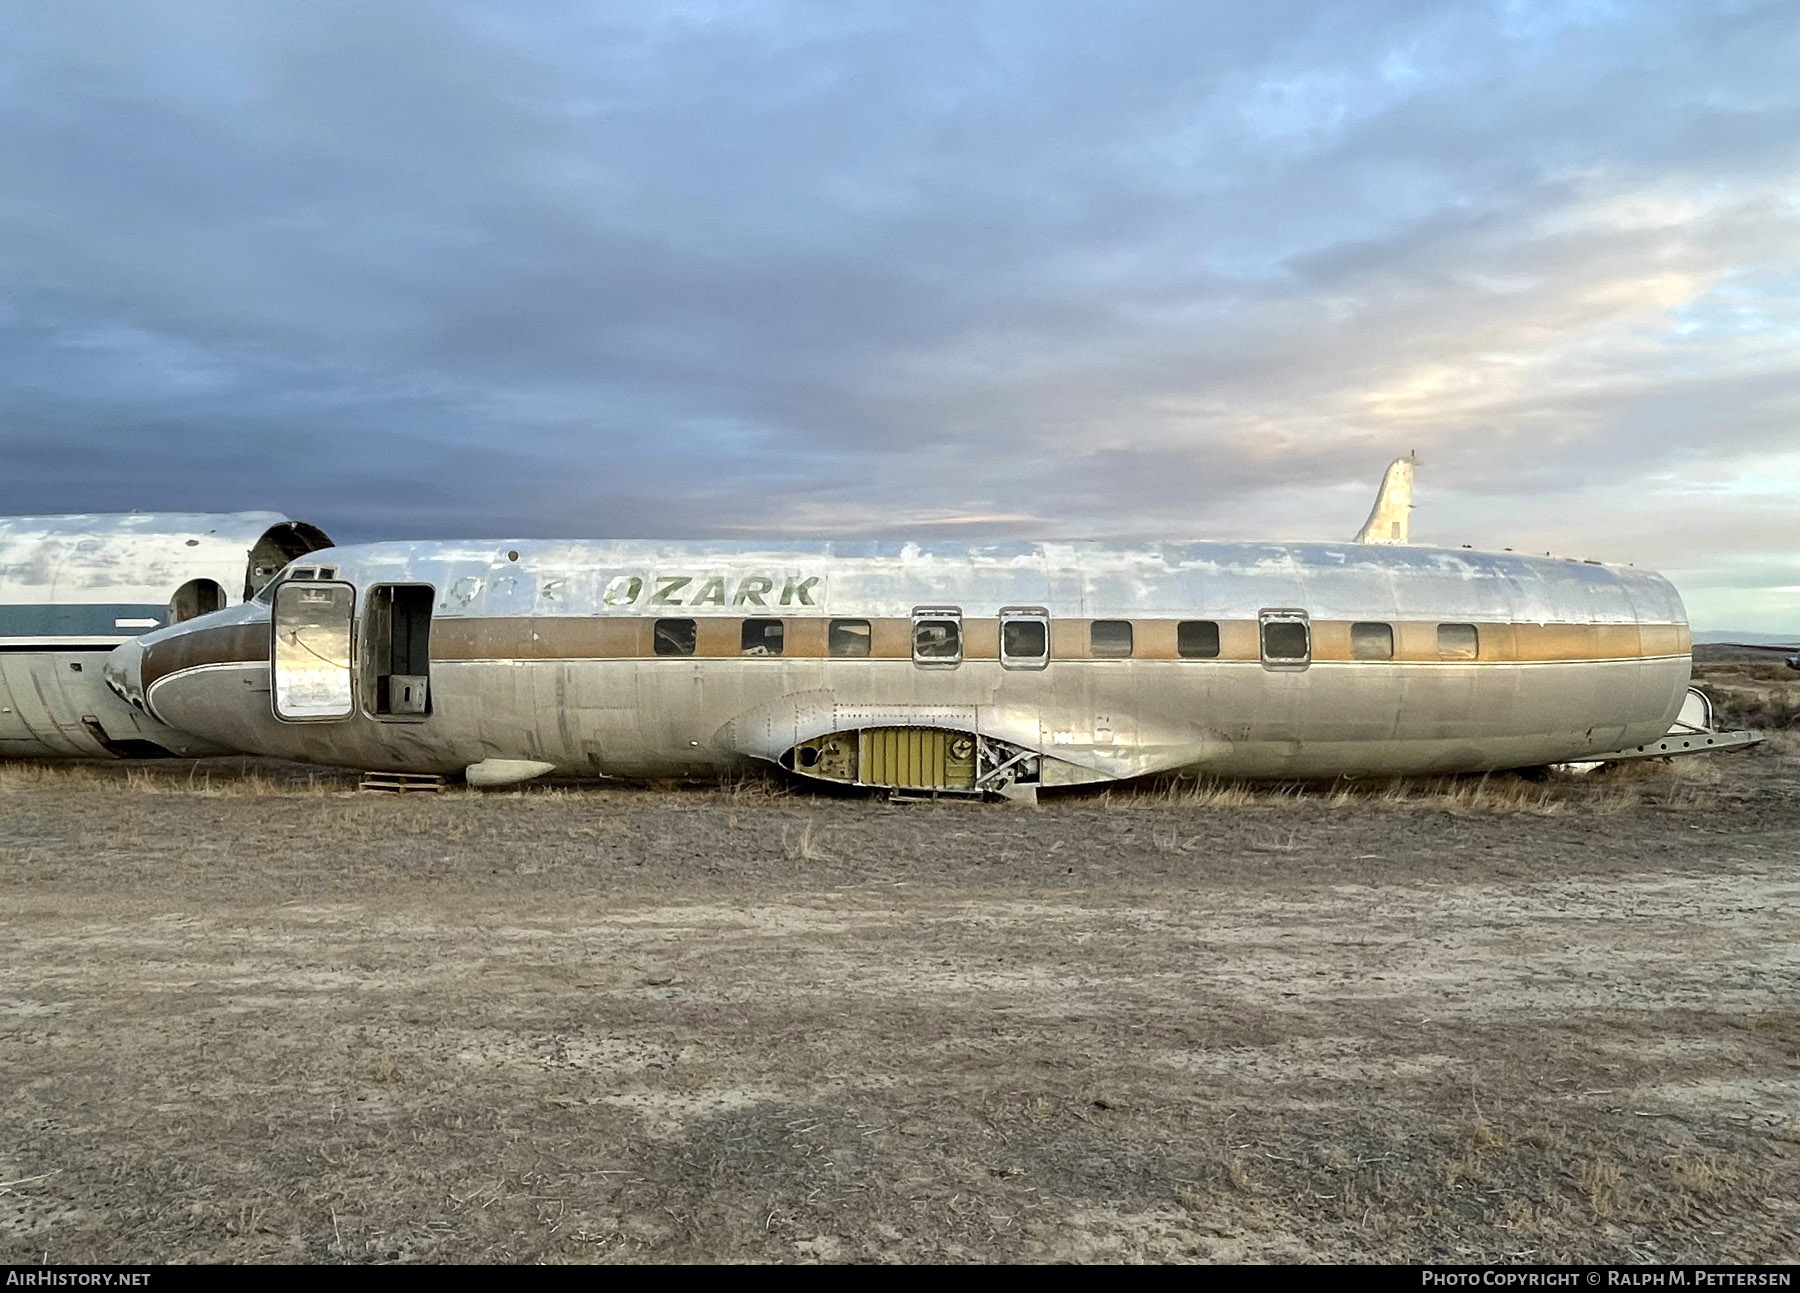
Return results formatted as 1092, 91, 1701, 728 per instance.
0, 0, 1800, 630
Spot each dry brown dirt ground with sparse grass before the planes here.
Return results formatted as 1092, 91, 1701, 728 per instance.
0, 669, 1800, 1262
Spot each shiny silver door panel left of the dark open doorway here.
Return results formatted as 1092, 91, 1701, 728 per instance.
268, 580, 356, 722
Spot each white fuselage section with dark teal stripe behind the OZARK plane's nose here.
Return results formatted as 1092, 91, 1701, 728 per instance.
0, 511, 324, 758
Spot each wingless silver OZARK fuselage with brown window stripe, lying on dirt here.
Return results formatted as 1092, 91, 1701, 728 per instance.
110, 542, 1690, 789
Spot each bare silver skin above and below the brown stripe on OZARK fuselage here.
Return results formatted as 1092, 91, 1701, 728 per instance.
110, 540, 1690, 785
